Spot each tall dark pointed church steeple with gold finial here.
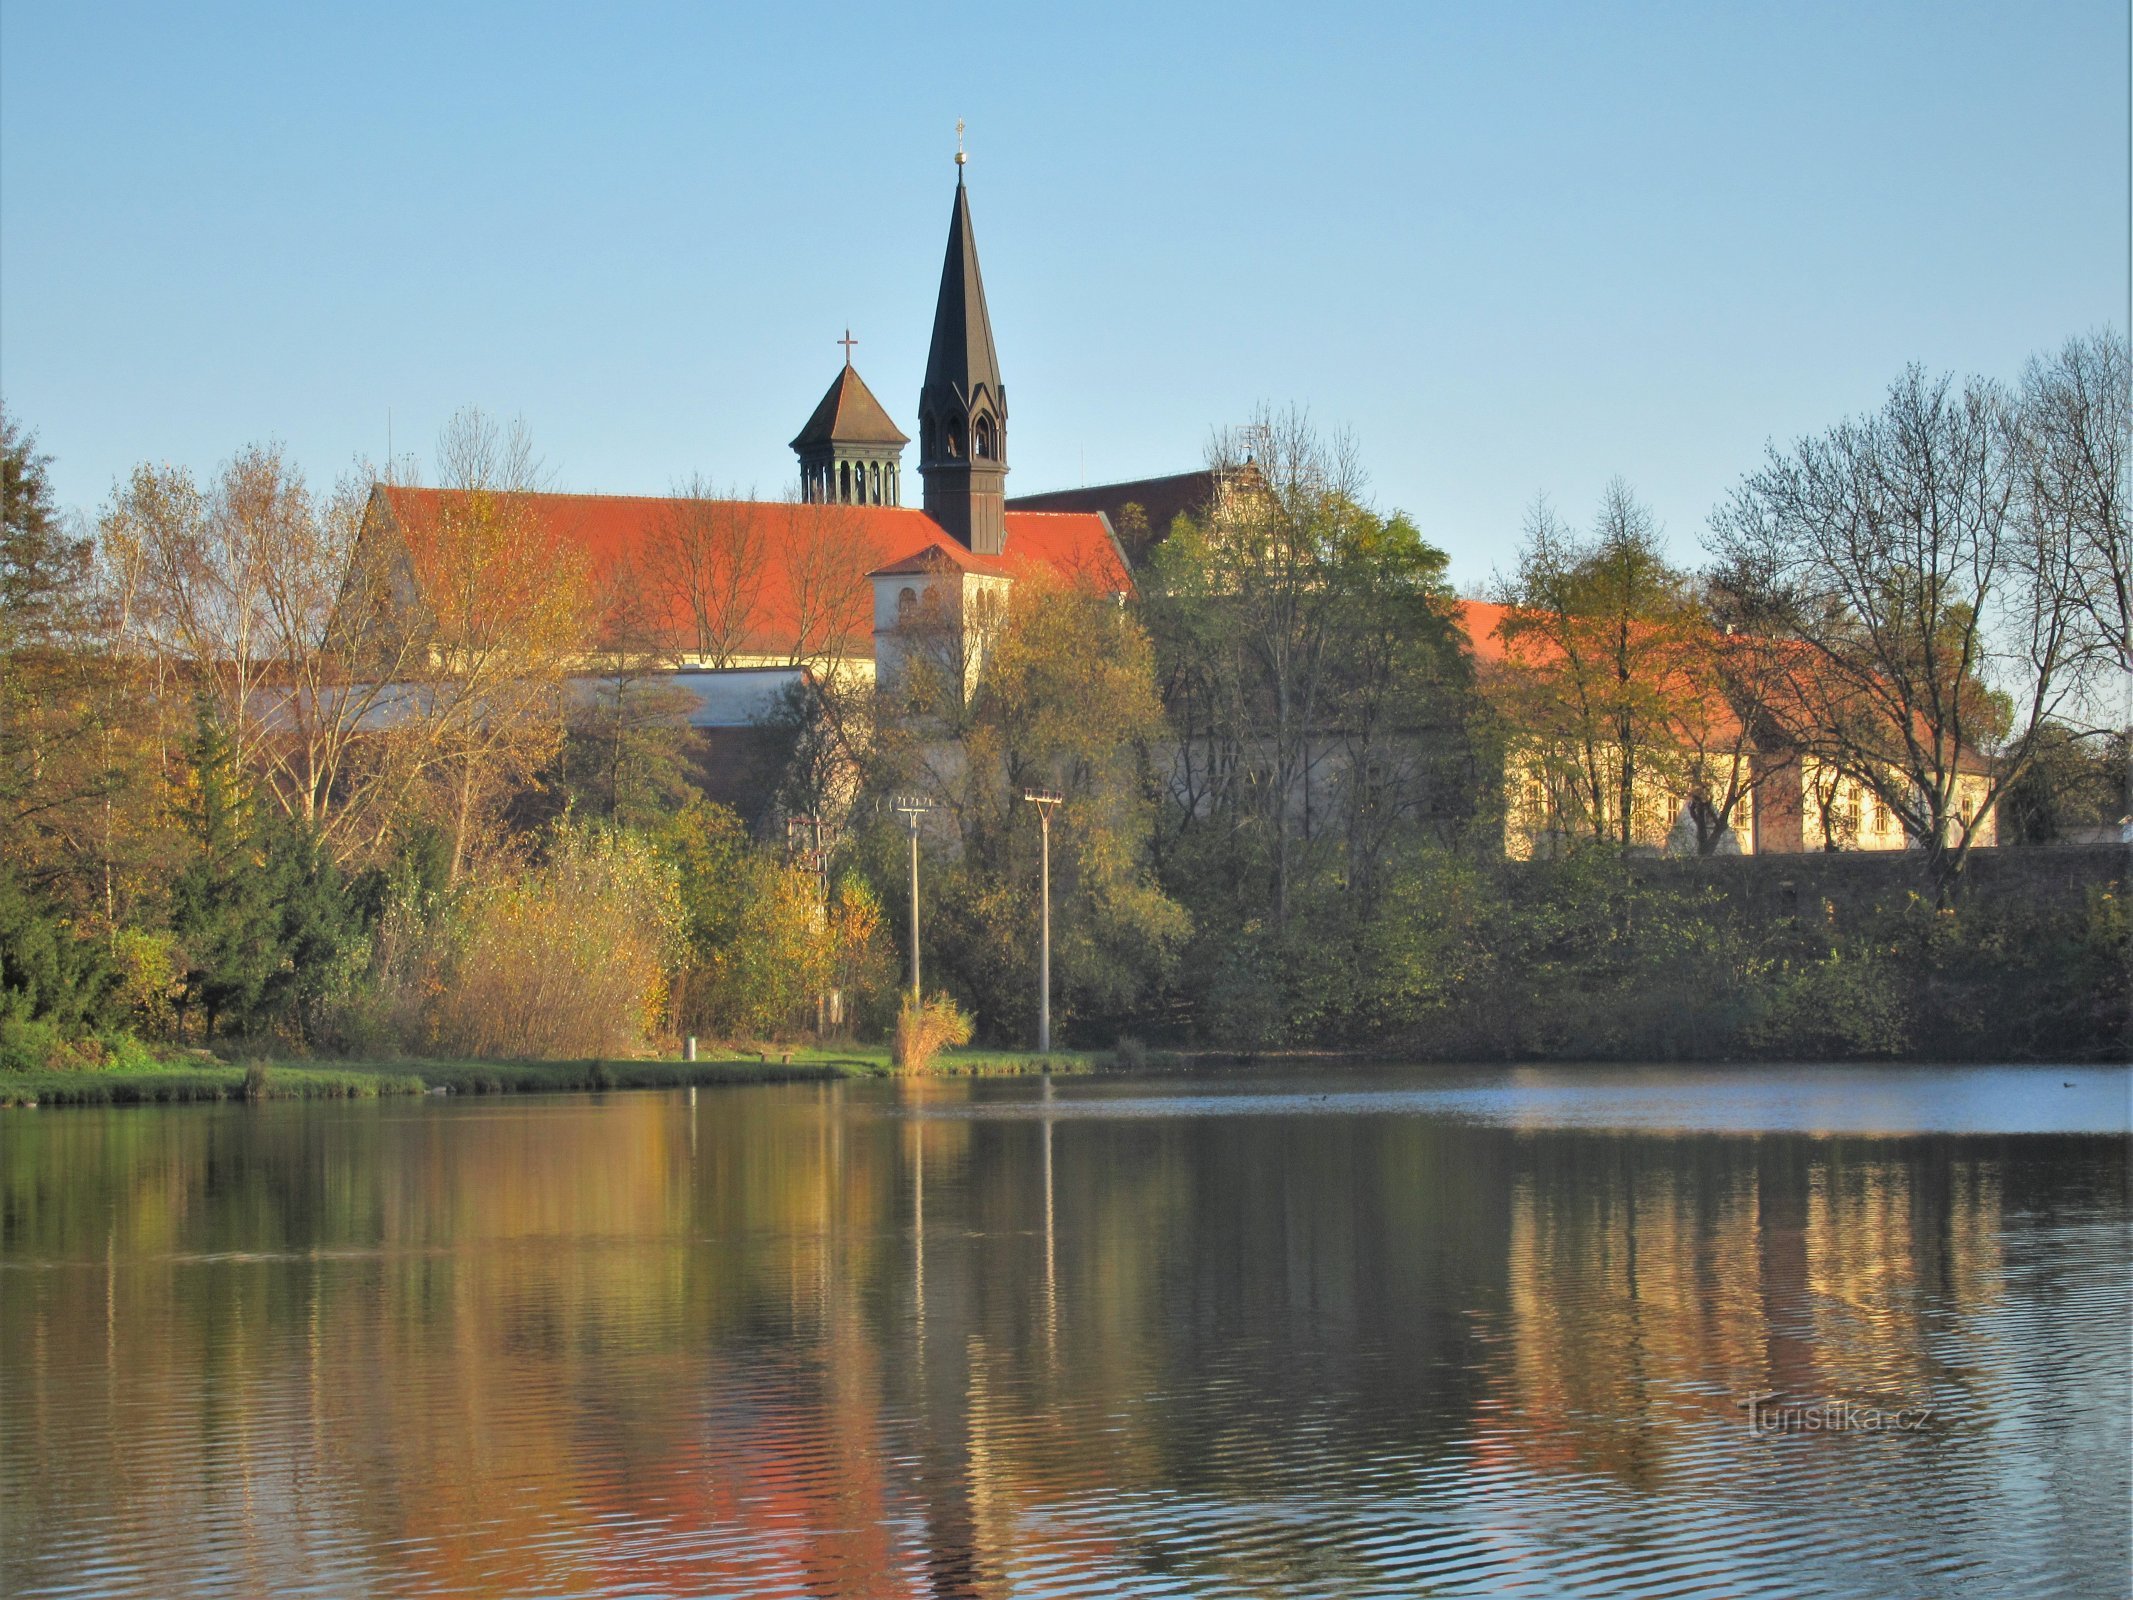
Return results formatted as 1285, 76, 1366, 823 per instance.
919, 146, 1007, 555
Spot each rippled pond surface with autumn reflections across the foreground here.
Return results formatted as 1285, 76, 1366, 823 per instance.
0, 1069, 2133, 1596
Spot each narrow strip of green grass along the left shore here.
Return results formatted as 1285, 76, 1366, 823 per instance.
0, 1045, 1105, 1105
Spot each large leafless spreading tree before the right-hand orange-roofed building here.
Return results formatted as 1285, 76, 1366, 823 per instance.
1711, 367, 2086, 898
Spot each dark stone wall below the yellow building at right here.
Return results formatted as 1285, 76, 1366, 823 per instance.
1632, 845, 2133, 917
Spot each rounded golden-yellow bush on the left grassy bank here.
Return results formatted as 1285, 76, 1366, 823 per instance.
429, 823, 680, 1058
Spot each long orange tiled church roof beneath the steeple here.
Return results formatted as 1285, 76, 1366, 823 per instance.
373, 484, 1133, 657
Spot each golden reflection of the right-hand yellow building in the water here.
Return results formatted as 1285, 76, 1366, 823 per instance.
1482, 1139, 2001, 1487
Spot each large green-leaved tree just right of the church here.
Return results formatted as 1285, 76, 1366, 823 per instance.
1139, 412, 1489, 1043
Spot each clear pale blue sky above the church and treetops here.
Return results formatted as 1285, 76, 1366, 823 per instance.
0, 0, 2129, 589
